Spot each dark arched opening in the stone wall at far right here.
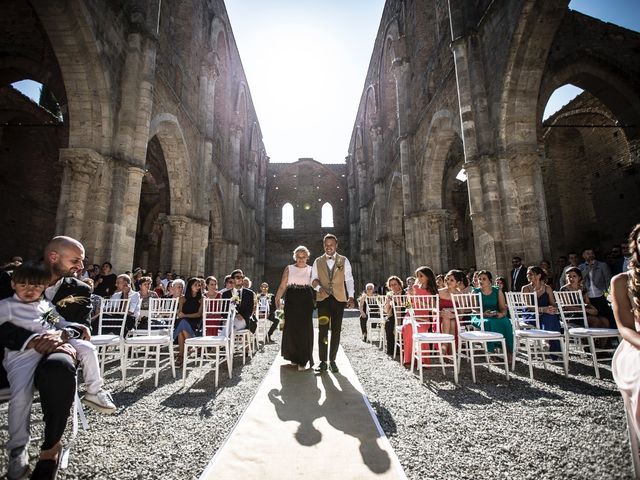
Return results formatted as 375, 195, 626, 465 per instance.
542, 88, 640, 257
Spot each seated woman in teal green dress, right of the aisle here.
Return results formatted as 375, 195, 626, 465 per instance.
472, 267, 512, 360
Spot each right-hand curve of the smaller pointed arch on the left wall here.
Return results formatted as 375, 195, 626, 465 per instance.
149, 113, 193, 215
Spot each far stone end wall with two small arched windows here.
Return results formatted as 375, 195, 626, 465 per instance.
264, 158, 350, 292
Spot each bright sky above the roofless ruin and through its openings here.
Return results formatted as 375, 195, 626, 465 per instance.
12, 0, 640, 163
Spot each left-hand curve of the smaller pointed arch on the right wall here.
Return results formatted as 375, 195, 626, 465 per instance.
418, 110, 461, 210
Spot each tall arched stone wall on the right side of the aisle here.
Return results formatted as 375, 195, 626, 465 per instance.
347, 0, 640, 283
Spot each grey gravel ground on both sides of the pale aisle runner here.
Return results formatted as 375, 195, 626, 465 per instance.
0, 319, 632, 479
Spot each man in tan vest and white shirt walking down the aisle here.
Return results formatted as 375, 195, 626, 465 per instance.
311, 233, 355, 373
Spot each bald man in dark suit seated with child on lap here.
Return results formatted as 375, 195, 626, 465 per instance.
0, 236, 91, 478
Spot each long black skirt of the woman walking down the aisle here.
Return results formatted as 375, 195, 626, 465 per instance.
282, 285, 313, 367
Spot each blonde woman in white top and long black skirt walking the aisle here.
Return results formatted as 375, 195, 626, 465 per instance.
276, 245, 313, 371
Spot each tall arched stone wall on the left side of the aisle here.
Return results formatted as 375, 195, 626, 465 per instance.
0, 0, 268, 276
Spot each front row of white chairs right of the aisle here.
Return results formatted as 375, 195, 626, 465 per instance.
384, 292, 619, 382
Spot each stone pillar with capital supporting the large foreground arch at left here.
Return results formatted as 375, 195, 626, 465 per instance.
56, 148, 104, 241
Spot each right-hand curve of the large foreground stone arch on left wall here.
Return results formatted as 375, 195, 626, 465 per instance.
31, 0, 113, 153
